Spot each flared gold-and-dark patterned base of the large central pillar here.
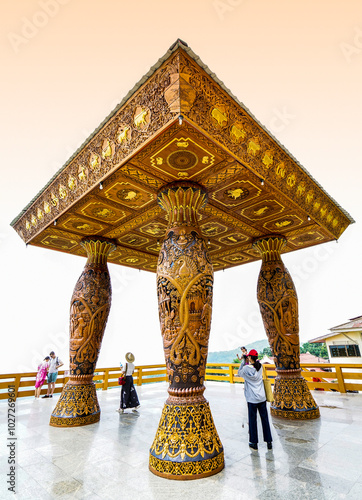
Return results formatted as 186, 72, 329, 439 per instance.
149, 400, 224, 481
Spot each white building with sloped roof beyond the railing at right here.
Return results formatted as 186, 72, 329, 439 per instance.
309, 316, 362, 364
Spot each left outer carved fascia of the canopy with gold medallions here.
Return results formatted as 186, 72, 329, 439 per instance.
14, 52, 179, 243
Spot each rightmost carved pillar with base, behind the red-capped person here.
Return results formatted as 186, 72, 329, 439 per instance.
253, 235, 320, 420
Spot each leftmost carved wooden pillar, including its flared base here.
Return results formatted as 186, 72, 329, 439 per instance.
50, 236, 115, 427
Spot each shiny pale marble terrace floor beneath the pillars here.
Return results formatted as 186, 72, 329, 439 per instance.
0, 382, 362, 500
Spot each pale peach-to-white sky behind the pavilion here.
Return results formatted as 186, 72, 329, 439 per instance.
0, 0, 362, 373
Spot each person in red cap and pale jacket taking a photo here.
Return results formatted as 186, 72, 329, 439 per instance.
238, 349, 273, 450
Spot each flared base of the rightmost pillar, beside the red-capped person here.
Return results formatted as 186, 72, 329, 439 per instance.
270, 377, 320, 420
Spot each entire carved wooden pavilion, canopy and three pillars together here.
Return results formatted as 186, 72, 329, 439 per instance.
12, 40, 353, 479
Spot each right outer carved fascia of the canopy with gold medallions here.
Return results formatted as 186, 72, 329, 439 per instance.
180, 51, 351, 238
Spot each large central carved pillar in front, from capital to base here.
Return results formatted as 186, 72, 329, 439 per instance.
150, 182, 224, 480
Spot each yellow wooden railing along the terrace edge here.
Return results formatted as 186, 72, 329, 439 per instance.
0, 363, 362, 400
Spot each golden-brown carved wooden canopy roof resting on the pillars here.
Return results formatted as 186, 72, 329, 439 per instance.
12, 40, 353, 271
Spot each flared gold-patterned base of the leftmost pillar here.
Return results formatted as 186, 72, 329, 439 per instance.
50, 382, 101, 427
